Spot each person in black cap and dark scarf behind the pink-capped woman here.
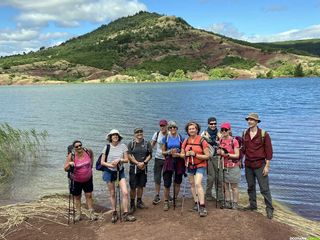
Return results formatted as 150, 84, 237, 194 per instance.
201, 117, 223, 202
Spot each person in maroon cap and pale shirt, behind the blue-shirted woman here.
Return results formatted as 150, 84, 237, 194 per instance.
151, 119, 168, 205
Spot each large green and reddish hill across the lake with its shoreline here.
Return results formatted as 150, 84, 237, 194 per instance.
0, 12, 320, 84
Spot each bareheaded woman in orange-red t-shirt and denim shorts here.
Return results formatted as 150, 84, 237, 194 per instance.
180, 122, 210, 217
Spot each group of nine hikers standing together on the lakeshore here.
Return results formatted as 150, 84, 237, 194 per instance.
64, 113, 274, 223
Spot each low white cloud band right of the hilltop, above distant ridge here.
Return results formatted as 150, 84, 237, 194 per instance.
206, 23, 320, 42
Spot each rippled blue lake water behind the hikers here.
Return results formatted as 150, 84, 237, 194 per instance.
0, 78, 320, 220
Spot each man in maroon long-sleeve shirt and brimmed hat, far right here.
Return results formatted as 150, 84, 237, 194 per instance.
243, 113, 274, 219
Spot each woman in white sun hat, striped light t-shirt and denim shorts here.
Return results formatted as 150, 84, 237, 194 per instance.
101, 129, 136, 223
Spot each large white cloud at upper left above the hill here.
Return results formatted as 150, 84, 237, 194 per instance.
0, 0, 147, 27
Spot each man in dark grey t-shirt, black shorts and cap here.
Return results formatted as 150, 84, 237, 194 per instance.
128, 128, 152, 213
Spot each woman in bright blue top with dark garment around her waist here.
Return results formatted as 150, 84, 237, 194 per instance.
162, 121, 185, 211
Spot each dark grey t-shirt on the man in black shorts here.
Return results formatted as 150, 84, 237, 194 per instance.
128, 139, 152, 165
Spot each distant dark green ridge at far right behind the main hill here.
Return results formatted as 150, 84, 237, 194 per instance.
257, 39, 320, 56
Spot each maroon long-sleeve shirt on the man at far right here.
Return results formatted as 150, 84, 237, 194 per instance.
244, 128, 273, 168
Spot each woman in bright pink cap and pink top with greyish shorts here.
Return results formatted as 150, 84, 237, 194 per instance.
217, 122, 241, 209
